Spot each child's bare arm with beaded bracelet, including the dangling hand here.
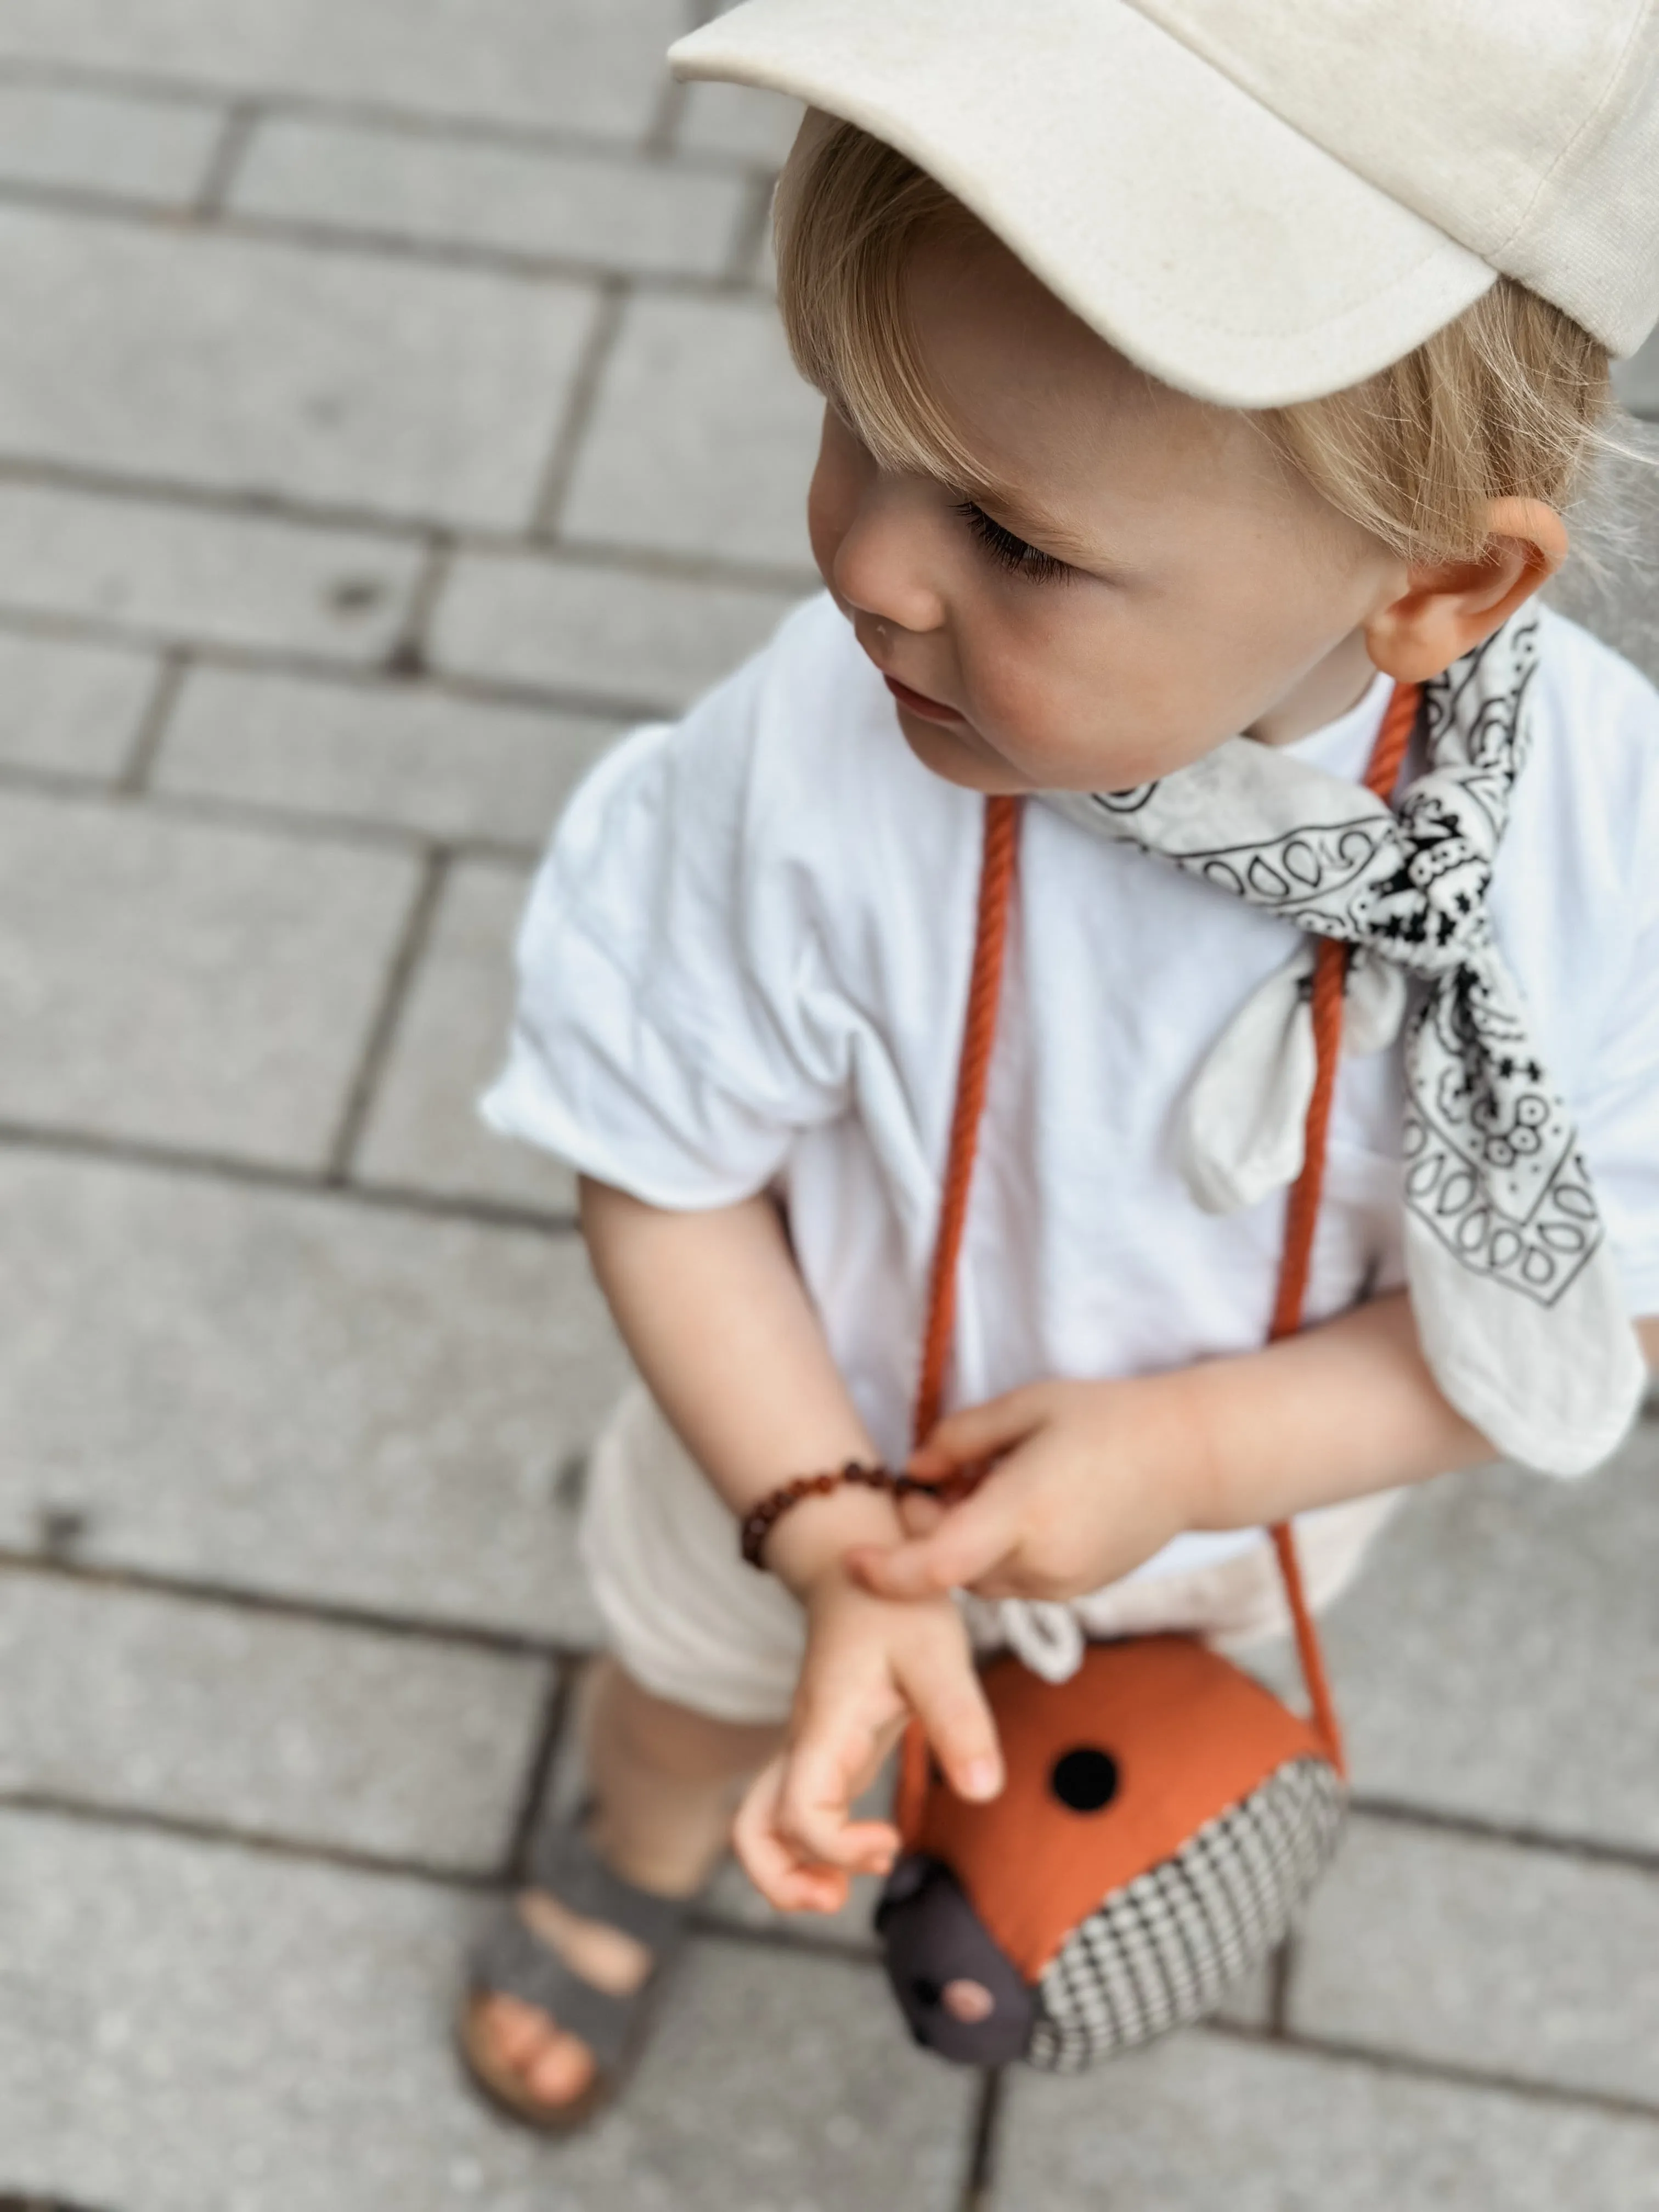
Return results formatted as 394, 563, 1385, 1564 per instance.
582, 1181, 1002, 1911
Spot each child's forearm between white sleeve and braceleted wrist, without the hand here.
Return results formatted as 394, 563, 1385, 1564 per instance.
582, 1179, 898, 1590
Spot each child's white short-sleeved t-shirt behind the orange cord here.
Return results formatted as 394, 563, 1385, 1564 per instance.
484, 597, 1659, 1573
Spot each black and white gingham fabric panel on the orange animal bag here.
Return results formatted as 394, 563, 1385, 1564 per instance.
1029, 1758, 1342, 2073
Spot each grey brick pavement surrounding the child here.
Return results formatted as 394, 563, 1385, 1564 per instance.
0, 0, 1659, 2212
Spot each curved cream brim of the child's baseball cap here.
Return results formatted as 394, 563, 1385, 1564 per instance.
668, 0, 1496, 407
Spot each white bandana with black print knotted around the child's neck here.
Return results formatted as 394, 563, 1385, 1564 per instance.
1042, 615, 1646, 1473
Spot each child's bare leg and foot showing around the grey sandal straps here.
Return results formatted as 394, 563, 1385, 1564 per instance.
473, 1659, 781, 2108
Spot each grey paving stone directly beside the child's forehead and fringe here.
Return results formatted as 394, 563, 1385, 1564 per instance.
560, 296, 823, 573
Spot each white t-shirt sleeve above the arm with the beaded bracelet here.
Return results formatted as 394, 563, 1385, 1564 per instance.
482, 662, 847, 1210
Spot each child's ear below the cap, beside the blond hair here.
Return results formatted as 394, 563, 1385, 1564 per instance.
1365, 500, 1566, 684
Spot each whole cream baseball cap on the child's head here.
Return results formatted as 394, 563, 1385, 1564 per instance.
668, 0, 1659, 407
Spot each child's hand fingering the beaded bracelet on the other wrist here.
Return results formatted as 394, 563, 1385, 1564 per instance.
847, 1376, 1203, 1599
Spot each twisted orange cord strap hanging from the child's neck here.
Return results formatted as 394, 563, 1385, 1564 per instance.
898, 684, 1420, 1796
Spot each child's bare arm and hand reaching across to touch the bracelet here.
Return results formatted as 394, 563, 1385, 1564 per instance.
849, 1292, 1659, 1597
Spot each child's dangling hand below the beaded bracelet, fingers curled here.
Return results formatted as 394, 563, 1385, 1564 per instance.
732, 1566, 1002, 1914
